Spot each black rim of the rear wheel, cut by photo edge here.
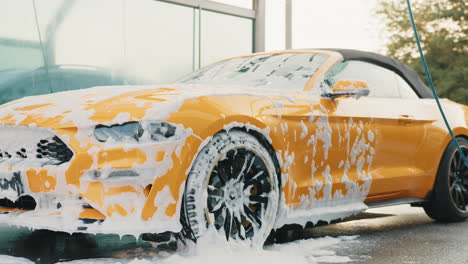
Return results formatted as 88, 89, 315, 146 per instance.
449, 147, 468, 212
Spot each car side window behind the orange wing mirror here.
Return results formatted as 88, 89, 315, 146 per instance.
325, 61, 401, 98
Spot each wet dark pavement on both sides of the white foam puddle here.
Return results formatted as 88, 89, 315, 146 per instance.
0, 205, 468, 264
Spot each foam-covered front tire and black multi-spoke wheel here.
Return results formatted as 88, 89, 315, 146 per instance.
181, 129, 279, 245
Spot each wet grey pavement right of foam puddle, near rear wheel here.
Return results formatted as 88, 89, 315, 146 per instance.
307, 205, 468, 264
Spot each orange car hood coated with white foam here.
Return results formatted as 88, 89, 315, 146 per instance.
0, 84, 296, 128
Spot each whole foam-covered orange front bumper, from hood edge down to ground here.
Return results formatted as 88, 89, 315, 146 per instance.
0, 122, 195, 235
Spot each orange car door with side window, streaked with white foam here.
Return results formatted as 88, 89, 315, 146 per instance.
256, 53, 433, 221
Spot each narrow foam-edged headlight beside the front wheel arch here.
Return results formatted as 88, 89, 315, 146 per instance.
94, 122, 176, 142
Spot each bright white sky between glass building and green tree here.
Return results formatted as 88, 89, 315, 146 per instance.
266, 0, 384, 52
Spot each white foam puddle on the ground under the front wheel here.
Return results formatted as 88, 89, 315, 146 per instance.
53, 231, 356, 264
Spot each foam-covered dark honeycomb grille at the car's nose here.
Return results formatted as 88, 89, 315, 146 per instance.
0, 126, 73, 168
